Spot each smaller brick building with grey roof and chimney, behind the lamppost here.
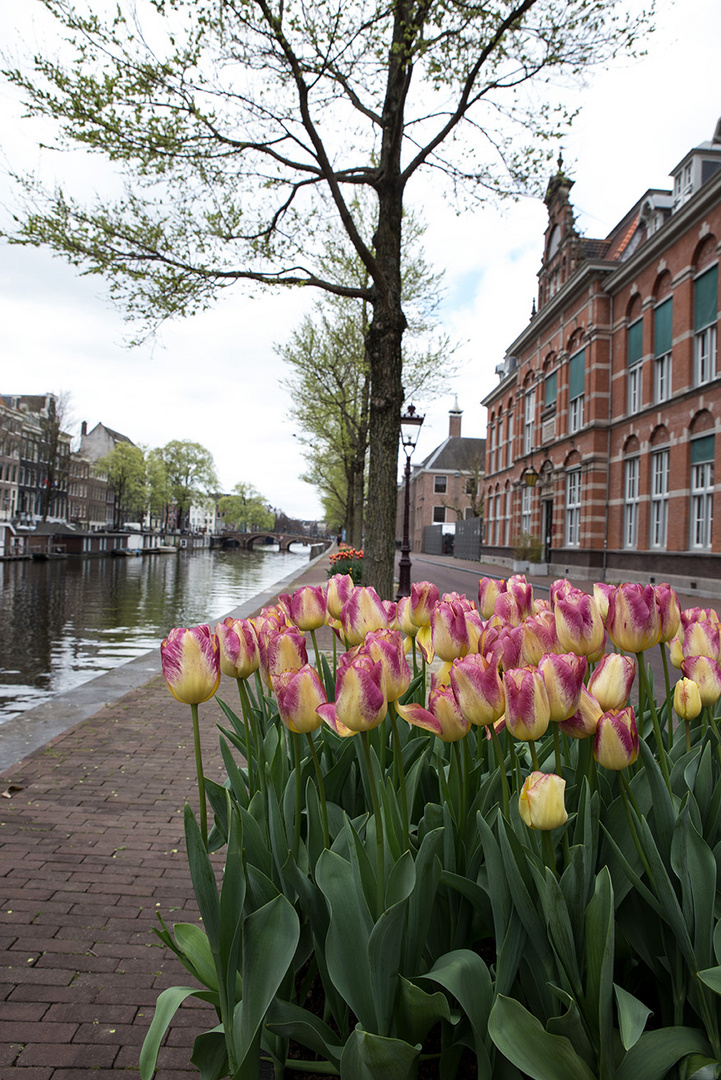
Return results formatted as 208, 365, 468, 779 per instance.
396, 401, 486, 551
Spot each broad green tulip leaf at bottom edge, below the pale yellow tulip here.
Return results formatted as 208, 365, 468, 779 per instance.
488, 995, 596, 1080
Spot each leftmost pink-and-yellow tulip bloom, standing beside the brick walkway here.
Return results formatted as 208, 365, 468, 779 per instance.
160, 624, 220, 705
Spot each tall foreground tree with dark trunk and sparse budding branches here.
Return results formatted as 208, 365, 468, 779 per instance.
5, 0, 653, 597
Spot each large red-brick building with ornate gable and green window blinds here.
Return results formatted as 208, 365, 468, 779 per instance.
484, 121, 721, 590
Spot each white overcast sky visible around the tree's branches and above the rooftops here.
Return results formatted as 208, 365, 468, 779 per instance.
0, 0, 721, 519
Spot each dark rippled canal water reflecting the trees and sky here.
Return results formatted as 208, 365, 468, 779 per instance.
0, 548, 309, 725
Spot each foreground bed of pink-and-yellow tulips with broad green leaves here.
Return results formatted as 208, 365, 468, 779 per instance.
140, 575, 721, 1080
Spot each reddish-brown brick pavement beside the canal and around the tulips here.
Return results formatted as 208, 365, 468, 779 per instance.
0, 556, 721, 1080
